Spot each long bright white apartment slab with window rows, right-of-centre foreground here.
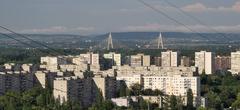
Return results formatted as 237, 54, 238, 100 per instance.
143, 75, 200, 97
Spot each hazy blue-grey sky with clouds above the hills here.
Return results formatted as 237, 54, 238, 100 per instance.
0, 0, 240, 35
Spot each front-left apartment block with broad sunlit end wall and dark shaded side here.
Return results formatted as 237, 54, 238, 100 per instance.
53, 77, 93, 106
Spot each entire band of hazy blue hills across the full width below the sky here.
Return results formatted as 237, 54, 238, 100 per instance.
0, 32, 240, 48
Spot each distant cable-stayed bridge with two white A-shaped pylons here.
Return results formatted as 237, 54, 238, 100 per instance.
92, 33, 164, 50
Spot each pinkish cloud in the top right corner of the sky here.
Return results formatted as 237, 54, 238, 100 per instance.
182, 1, 240, 12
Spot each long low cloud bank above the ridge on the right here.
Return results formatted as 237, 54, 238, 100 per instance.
122, 23, 240, 33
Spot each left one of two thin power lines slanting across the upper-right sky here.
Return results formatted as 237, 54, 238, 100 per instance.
136, 0, 213, 40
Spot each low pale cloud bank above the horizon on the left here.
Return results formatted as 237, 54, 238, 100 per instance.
19, 26, 94, 33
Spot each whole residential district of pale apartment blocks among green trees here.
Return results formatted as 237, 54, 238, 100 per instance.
0, 50, 240, 108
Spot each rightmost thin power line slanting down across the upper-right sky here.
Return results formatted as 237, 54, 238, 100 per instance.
160, 0, 230, 40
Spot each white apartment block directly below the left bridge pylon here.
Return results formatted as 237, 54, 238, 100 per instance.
103, 52, 121, 66
